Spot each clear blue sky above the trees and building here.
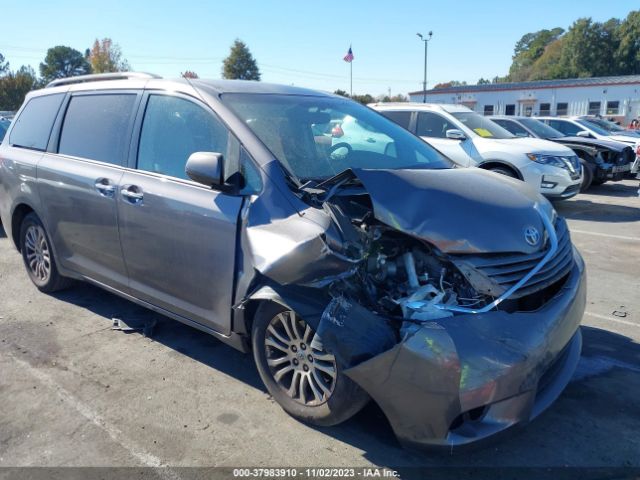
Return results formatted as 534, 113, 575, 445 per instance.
0, 0, 640, 96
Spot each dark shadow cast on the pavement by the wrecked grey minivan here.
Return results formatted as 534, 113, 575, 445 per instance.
47, 278, 640, 472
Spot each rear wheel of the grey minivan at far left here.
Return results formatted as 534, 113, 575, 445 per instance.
20, 213, 72, 293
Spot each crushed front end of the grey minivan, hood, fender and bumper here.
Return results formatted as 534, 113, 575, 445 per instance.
236, 166, 586, 446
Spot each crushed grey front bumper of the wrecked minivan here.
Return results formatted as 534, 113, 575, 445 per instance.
345, 250, 586, 447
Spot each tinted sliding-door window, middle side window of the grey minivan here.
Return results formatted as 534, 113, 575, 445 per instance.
58, 93, 136, 165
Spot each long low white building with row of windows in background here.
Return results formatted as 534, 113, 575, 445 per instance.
409, 75, 640, 124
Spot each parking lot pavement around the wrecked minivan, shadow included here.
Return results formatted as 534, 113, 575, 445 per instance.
0, 180, 640, 474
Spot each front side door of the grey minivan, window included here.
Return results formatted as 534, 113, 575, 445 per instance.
117, 94, 243, 334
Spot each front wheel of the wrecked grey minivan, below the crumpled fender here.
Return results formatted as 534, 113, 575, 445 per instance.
252, 302, 369, 426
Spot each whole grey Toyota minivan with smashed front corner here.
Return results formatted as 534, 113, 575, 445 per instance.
0, 73, 586, 449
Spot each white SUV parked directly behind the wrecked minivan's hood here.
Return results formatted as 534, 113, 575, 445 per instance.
371, 103, 582, 200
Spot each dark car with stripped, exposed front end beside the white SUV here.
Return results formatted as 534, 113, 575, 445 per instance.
489, 115, 635, 192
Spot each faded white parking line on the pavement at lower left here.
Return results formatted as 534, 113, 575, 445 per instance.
9, 353, 181, 480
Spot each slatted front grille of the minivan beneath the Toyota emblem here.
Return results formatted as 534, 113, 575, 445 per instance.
452, 218, 573, 299
